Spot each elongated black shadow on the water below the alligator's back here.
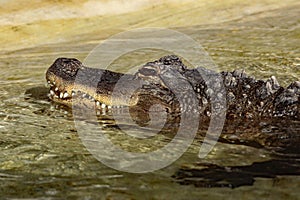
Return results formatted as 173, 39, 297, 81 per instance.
173, 158, 300, 188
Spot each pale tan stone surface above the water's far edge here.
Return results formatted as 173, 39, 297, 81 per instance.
0, 0, 300, 52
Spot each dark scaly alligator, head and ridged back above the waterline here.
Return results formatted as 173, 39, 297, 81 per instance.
46, 55, 300, 119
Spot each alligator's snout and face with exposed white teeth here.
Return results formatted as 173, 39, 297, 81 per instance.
46, 58, 179, 111
